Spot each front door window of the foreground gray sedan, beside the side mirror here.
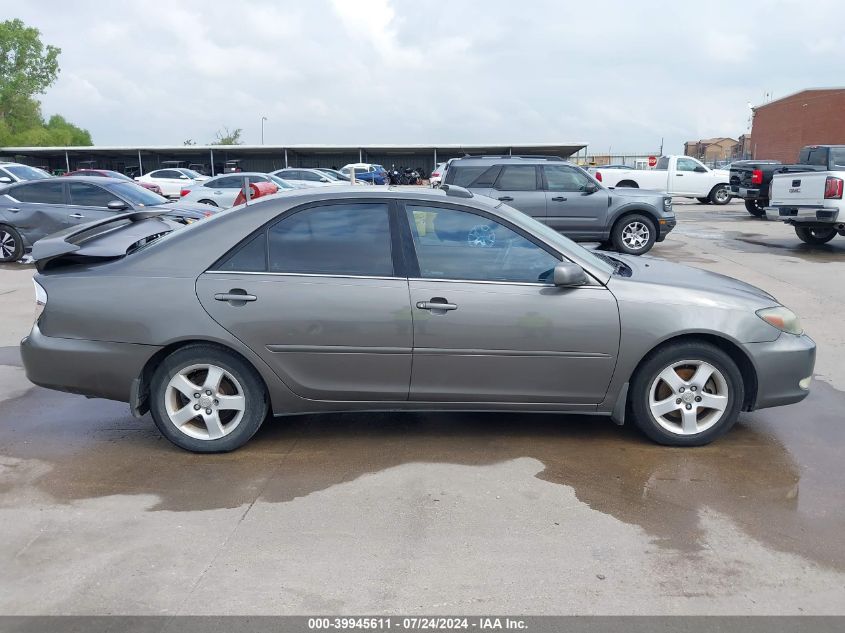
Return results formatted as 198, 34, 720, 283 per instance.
406, 206, 560, 283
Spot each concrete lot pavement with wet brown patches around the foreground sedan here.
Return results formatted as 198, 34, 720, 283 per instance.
0, 201, 845, 615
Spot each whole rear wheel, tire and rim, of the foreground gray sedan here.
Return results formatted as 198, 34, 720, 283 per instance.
150, 345, 268, 453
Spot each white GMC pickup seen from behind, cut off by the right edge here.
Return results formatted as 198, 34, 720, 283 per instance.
766, 145, 845, 244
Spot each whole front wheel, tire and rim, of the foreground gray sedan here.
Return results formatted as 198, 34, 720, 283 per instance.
629, 342, 744, 446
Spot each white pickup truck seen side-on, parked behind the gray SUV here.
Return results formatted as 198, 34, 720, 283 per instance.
589, 156, 731, 205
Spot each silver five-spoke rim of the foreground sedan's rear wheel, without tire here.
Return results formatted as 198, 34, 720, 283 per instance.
164, 364, 246, 440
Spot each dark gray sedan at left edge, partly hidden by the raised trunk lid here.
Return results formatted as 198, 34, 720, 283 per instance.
0, 176, 215, 262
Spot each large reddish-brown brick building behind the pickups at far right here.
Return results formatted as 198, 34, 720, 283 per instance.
751, 88, 845, 163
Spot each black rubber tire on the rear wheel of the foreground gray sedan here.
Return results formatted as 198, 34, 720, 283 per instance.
150, 344, 268, 453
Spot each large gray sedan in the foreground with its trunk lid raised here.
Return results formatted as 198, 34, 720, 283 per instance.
21, 186, 815, 452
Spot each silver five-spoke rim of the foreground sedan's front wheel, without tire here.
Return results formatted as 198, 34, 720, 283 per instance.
648, 360, 729, 435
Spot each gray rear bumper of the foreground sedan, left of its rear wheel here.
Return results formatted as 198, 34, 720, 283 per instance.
21, 324, 161, 402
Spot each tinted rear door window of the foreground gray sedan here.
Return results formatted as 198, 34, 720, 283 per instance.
268, 204, 393, 277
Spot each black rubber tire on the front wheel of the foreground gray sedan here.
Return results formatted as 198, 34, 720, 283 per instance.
628, 341, 745, 446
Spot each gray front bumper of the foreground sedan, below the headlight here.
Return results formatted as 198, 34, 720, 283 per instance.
743, 333, 816, 409
